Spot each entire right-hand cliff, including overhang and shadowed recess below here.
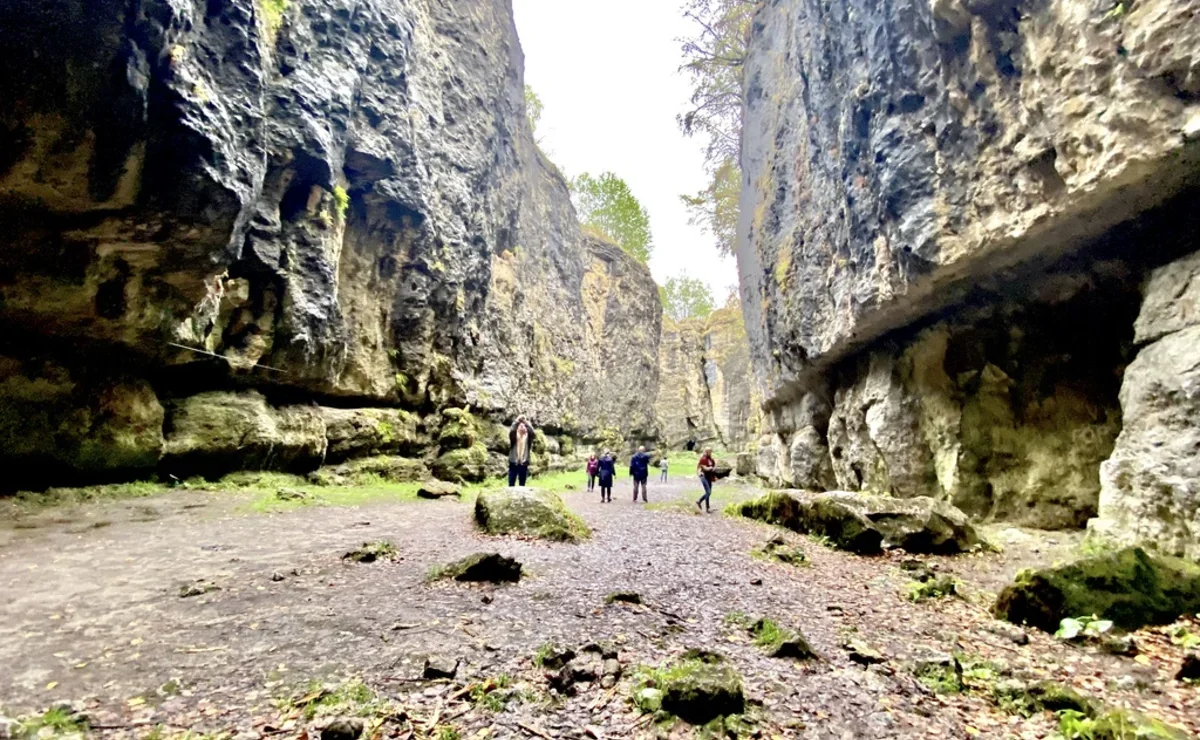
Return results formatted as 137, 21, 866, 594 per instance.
739, 0, 1200, 554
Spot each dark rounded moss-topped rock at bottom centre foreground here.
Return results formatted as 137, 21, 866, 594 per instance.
660, 650, 745, 724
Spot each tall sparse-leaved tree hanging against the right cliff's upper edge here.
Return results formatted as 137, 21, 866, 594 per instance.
678, 0, 758, 254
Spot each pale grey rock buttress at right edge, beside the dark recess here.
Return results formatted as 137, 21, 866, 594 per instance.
1090, 255, 1200, 560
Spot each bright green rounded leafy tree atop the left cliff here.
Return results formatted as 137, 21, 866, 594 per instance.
571, 173, 654, 264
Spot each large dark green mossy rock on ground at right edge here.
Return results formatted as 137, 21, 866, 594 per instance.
992, 547, 1200, 632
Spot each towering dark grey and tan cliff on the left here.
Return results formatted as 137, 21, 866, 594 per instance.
0, 0, 661, 477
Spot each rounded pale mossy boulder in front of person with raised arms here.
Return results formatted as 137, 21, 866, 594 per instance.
475, 488, 592, 542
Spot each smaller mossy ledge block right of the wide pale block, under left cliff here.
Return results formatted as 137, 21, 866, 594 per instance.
319, 407, 430, 464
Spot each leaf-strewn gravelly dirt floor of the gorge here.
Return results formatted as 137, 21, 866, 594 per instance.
0, 479, 1200, 740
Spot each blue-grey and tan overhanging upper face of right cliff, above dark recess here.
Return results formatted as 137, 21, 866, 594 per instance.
738, 0, 1200, 403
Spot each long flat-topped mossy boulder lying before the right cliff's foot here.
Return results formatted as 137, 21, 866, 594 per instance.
737, 491, 980, 554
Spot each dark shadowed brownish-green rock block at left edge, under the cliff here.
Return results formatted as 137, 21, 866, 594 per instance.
0, 356, 163, 483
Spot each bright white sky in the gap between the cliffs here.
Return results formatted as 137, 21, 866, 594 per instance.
512, 0, 737, 299
